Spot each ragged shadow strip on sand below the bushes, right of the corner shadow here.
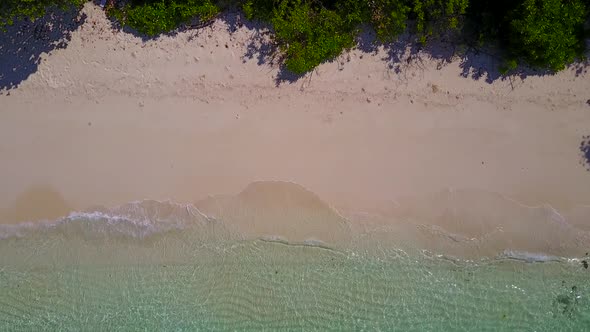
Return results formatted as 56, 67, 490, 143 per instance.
102, 9, 588, 86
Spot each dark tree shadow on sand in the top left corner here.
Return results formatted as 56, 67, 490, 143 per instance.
0, 8, 86, 93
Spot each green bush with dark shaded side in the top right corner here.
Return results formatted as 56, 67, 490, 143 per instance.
467, 0, 590, 72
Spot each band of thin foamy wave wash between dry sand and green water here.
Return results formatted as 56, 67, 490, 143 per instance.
0, 181, 590, 262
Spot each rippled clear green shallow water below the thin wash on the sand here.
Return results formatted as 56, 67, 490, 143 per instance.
0, 198, 590, 331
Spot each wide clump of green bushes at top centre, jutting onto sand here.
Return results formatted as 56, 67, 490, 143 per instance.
242, 0, 467, 73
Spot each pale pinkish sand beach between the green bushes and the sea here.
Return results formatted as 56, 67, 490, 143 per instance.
0, 4, 590, 255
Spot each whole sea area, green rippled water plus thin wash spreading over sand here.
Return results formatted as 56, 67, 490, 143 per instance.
0, 183, 590, 331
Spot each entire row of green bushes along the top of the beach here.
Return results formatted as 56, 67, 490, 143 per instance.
0, 0, 590, 74
